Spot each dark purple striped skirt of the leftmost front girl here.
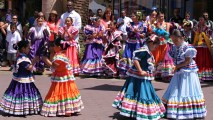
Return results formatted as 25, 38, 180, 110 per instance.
0, 80, 43, 115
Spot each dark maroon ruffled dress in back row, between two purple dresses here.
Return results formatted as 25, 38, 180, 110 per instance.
102, 30, 122, 77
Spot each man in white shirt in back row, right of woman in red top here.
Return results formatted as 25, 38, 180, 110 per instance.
117, 10, 132, 50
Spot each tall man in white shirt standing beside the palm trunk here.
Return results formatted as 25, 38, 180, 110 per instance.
59, 0, 82, 50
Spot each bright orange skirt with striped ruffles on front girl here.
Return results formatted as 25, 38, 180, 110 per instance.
41, 81, 84, 116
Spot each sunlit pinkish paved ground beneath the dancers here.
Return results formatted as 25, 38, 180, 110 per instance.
0, 68, 213, 120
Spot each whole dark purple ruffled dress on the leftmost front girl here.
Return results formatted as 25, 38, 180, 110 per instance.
0, 53, 43, 115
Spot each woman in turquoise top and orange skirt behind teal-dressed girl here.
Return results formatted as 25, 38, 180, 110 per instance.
152, 12, 174, 81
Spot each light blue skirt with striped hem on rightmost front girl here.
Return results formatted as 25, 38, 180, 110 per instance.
163, 71, 207, 119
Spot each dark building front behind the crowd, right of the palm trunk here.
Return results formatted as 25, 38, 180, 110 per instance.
89, 0, 213, 20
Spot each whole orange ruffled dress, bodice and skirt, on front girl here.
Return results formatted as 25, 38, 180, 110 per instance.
41, 53, 84, 116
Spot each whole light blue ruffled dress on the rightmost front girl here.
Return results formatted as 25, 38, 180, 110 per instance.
163, 42, 207, 120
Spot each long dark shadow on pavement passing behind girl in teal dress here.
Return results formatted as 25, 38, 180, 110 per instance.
84, 84, 162, 91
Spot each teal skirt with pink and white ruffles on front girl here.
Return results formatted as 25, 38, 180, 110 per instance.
112, 77, 166, 120
